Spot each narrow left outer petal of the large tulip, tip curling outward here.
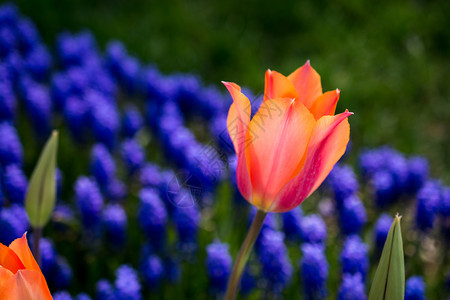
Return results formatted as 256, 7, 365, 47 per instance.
223, 82, 252, 203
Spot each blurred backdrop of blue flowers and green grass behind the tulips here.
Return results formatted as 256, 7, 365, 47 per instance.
0, 0, 450, 300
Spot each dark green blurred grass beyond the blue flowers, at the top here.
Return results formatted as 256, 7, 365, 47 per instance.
16, 0, 450, 180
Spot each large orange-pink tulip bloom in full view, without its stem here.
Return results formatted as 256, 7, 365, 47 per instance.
223, 61, 352, 212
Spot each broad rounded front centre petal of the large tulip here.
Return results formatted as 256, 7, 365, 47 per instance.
245, 99, 315, 210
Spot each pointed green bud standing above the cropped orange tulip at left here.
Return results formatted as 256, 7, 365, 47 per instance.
25, 131, 58, 228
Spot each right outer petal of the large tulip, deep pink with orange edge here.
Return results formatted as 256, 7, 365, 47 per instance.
270, 111, 353, 212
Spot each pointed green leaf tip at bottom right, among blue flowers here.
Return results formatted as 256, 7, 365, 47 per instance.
369, 214, 405, 300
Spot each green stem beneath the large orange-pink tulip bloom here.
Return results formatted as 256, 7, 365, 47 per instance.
225, 210, 267, 300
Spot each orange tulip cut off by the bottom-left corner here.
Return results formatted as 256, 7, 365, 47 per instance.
0, 233, 53, 300
